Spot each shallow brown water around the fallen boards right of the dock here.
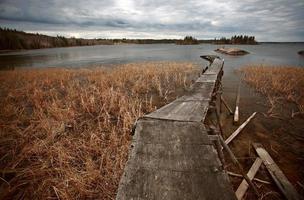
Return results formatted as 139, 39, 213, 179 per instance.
221, 65, 304, 200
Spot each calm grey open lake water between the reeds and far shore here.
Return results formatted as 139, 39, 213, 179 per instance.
0, 43, 304, 69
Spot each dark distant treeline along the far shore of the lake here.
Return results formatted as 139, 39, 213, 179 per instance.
0, 27, 257, 50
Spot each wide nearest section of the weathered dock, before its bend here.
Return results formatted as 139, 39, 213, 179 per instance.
117, 119, 235, 199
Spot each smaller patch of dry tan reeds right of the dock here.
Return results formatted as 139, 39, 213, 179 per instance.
240, 65, 304, 114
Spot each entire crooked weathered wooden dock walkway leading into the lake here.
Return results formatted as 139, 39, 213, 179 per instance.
116, 57, 236, 200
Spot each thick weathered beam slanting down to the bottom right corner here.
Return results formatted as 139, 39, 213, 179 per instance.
252, 143, 300, 200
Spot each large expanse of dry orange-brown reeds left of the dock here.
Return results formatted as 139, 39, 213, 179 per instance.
0, 62, 198, 199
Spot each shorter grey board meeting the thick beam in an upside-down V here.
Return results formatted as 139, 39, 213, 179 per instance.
235, 158, 262, 200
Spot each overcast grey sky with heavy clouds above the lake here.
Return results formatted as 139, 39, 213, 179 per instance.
0, 0, 304, 41
